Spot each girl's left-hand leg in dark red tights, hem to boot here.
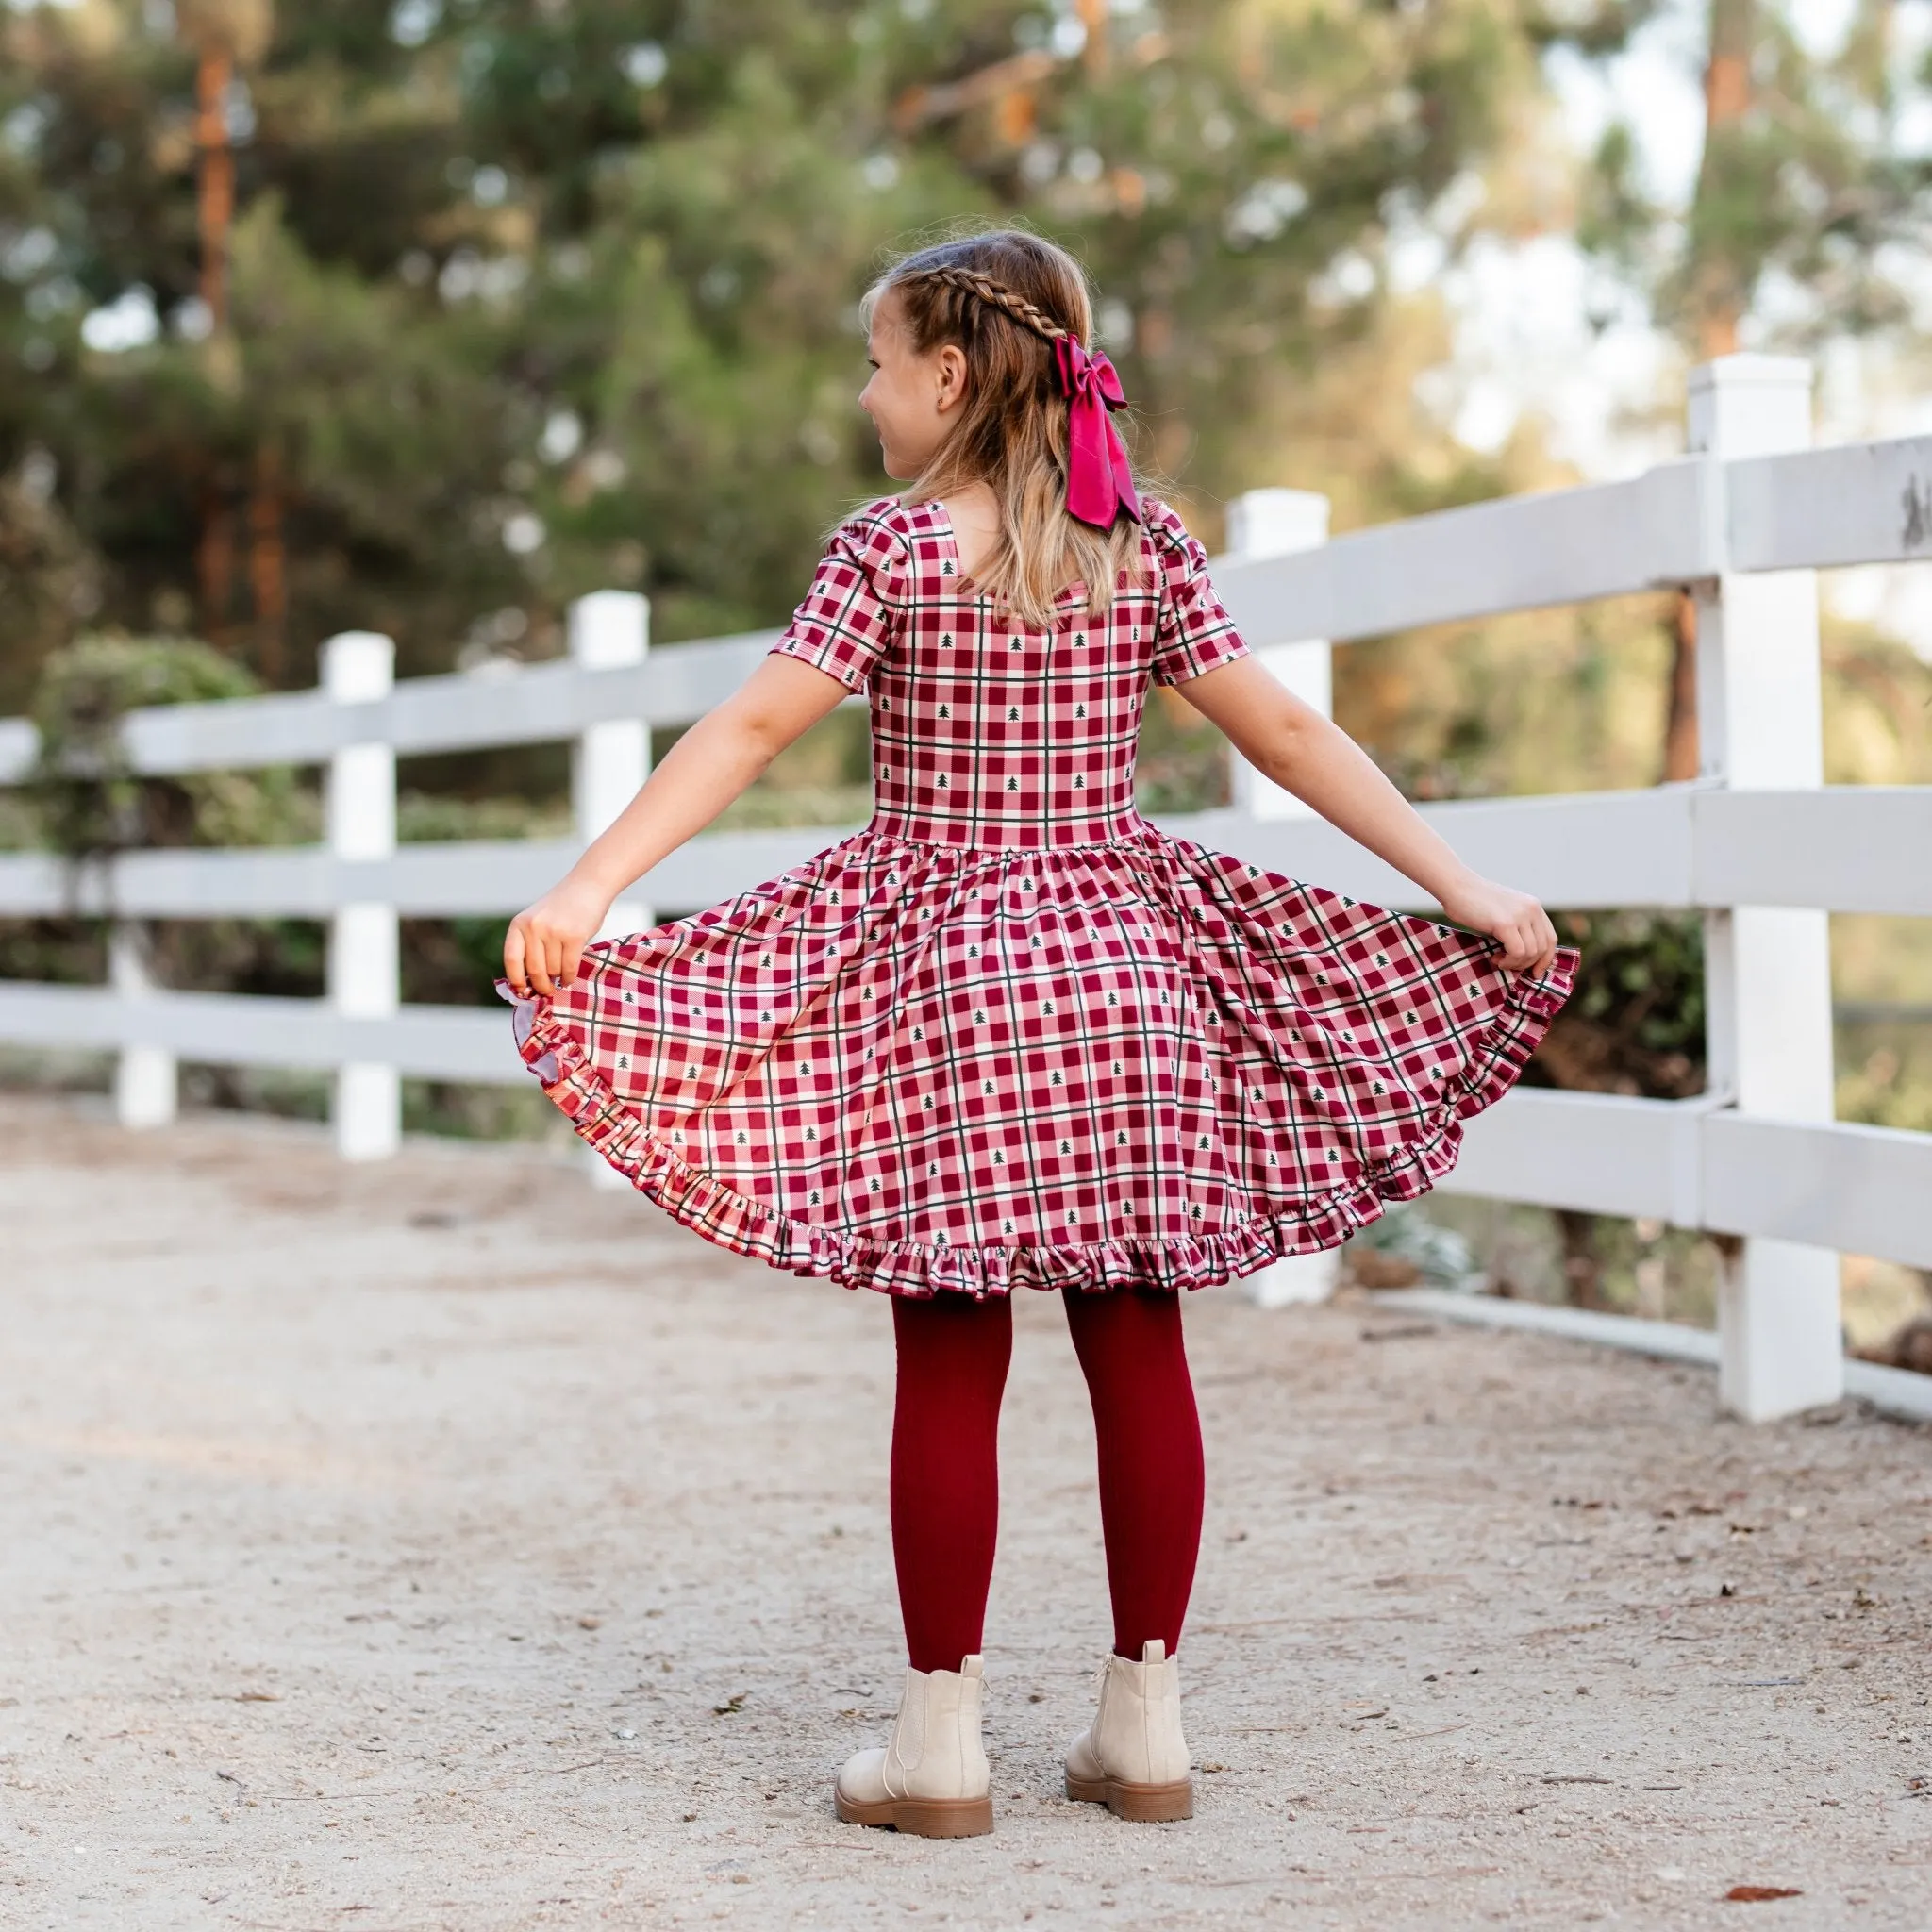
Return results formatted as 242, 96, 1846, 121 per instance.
892, 1292, 1012, 1672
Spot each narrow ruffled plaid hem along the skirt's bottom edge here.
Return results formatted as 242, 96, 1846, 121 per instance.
496, 947, 1578, 1300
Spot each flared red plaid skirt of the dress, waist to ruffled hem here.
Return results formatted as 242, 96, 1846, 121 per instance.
498, 824, 1576, 1296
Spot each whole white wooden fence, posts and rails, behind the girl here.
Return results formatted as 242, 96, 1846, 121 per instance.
0, 356, 1932, 1418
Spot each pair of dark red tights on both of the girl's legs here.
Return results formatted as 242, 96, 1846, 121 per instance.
892, 1289, 1202, 1672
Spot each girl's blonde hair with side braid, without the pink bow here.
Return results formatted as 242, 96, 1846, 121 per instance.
859, 228, 1141, 628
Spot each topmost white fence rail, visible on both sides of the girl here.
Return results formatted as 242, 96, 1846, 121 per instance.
0, 423, 1932, 784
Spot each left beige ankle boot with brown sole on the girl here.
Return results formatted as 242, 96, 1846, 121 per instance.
833, 1654, 993, 1838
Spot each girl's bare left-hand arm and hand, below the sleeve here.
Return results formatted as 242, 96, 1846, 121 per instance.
502, 655, 852, 997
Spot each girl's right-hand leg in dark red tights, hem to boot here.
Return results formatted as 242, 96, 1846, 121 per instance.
1062, 1289, 1204, 1663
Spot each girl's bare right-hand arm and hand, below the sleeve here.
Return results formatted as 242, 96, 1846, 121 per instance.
1174, 657, 1557, 974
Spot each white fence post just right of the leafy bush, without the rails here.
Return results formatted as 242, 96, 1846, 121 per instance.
323, 630, 402, 1161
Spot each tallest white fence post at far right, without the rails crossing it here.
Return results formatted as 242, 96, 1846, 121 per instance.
1689, 356, 1845, 1422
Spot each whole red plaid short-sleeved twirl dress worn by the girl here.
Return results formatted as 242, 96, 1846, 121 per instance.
505, 496, 1576, 1296
